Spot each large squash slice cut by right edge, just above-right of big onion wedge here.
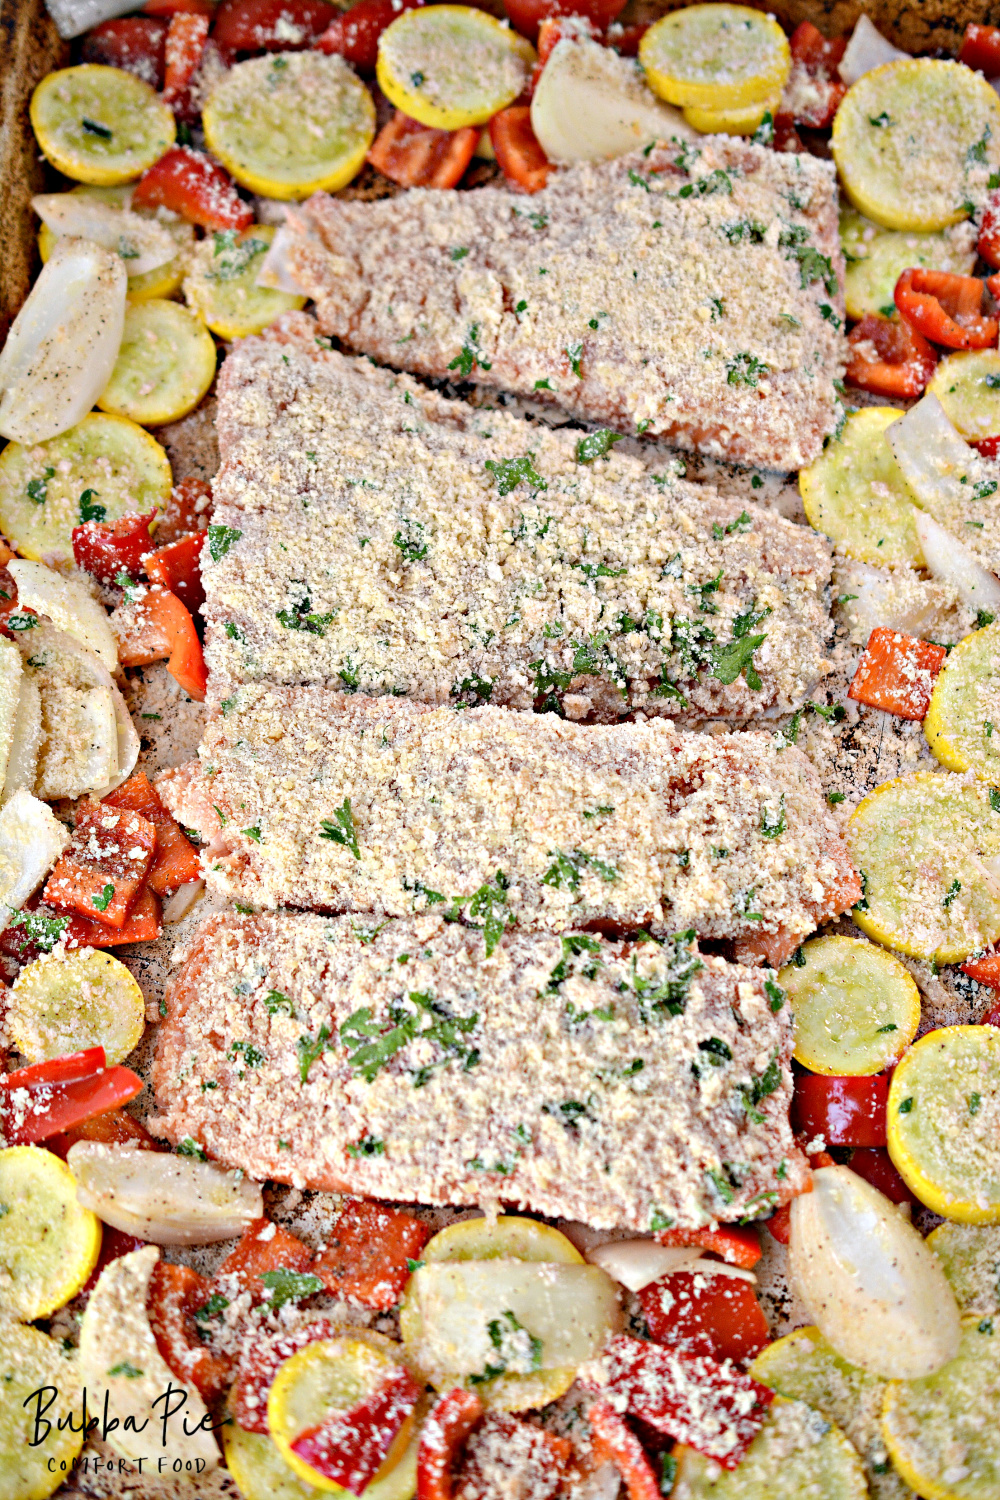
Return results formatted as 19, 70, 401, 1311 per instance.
888, 1026, 1000, 1224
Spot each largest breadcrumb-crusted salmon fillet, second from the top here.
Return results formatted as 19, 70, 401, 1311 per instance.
204, 314, 832, 722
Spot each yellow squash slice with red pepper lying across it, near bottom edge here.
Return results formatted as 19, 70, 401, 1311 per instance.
267, 1329, 417, 1500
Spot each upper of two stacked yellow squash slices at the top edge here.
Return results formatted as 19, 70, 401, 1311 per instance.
639, 5, 792, 110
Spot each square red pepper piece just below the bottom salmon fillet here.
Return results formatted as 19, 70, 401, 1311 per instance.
312, 1199, 430, 1311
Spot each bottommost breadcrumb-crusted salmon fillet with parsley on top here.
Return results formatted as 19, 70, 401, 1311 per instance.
153, 912, 807, 1230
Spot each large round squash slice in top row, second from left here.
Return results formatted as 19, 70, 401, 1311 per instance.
202, 53, 375, 198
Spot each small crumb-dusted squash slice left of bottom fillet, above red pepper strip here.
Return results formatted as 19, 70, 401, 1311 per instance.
7, 948, 145, 1068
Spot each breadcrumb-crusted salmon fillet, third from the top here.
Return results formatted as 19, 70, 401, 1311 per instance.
157, 684, 861, 963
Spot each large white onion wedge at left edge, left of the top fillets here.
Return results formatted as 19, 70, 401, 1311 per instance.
0, 240, 127, 444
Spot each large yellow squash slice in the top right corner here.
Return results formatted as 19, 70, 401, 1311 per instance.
832, 57, 1000, 231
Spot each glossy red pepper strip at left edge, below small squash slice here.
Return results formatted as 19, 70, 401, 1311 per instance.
0, 1047, 142, 1146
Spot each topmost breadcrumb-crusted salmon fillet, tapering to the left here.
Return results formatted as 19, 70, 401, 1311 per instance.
288, 137, 846, 470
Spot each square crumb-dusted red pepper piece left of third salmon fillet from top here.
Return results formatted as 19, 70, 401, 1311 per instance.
42, 803, 156, 927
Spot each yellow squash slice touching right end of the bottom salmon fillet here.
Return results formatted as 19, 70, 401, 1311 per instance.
778, 936, 921, 1077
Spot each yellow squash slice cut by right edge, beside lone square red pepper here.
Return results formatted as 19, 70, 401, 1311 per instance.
924, 623, 1000, 786
